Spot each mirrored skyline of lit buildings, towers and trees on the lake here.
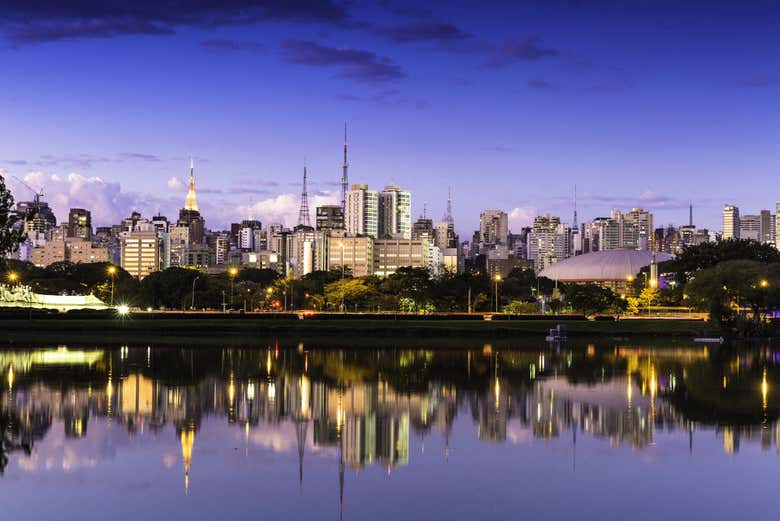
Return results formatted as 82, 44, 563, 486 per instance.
0, 344, 780, 504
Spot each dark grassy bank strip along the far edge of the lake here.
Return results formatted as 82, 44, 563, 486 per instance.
0, 316, 718, 345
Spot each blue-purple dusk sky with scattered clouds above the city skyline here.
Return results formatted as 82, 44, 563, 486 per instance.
0, 0, 780, 234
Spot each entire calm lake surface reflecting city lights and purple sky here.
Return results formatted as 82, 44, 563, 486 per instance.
0, 342, 780, 519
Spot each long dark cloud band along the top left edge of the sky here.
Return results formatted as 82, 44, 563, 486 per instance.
0, 0, 350, 46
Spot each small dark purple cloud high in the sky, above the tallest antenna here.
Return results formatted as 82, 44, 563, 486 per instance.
282, 40, 406, 83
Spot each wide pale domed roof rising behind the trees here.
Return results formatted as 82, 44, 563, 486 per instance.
539, 250, 672, 282
